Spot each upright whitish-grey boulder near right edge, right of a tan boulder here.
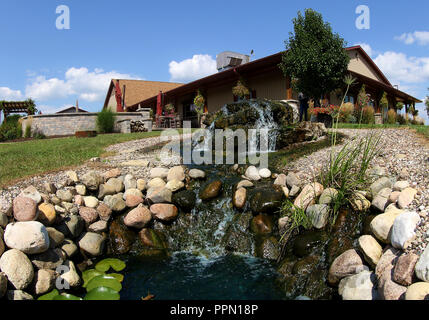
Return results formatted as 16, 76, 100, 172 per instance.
390, 212, 420, 249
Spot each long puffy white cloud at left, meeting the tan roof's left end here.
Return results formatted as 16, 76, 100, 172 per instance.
25, 67, 138, 102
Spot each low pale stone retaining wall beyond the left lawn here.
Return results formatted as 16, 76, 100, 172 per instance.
22, 110, 152, 137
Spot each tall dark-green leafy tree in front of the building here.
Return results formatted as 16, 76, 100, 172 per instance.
280, 9, 350, 102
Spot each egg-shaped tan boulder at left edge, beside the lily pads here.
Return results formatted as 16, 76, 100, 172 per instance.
0, 249, 34, 290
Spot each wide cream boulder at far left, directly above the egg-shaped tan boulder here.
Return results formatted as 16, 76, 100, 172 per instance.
4, 221, 49, 254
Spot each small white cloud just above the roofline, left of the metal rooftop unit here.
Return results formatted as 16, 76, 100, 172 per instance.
169, 54, 217, 82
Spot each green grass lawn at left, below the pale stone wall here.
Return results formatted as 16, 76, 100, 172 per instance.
0, 131, 166, 187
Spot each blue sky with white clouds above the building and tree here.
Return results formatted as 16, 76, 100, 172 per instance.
0, 0, 429, 123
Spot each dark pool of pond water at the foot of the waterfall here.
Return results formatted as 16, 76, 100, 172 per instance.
121, 252, 284, 300
